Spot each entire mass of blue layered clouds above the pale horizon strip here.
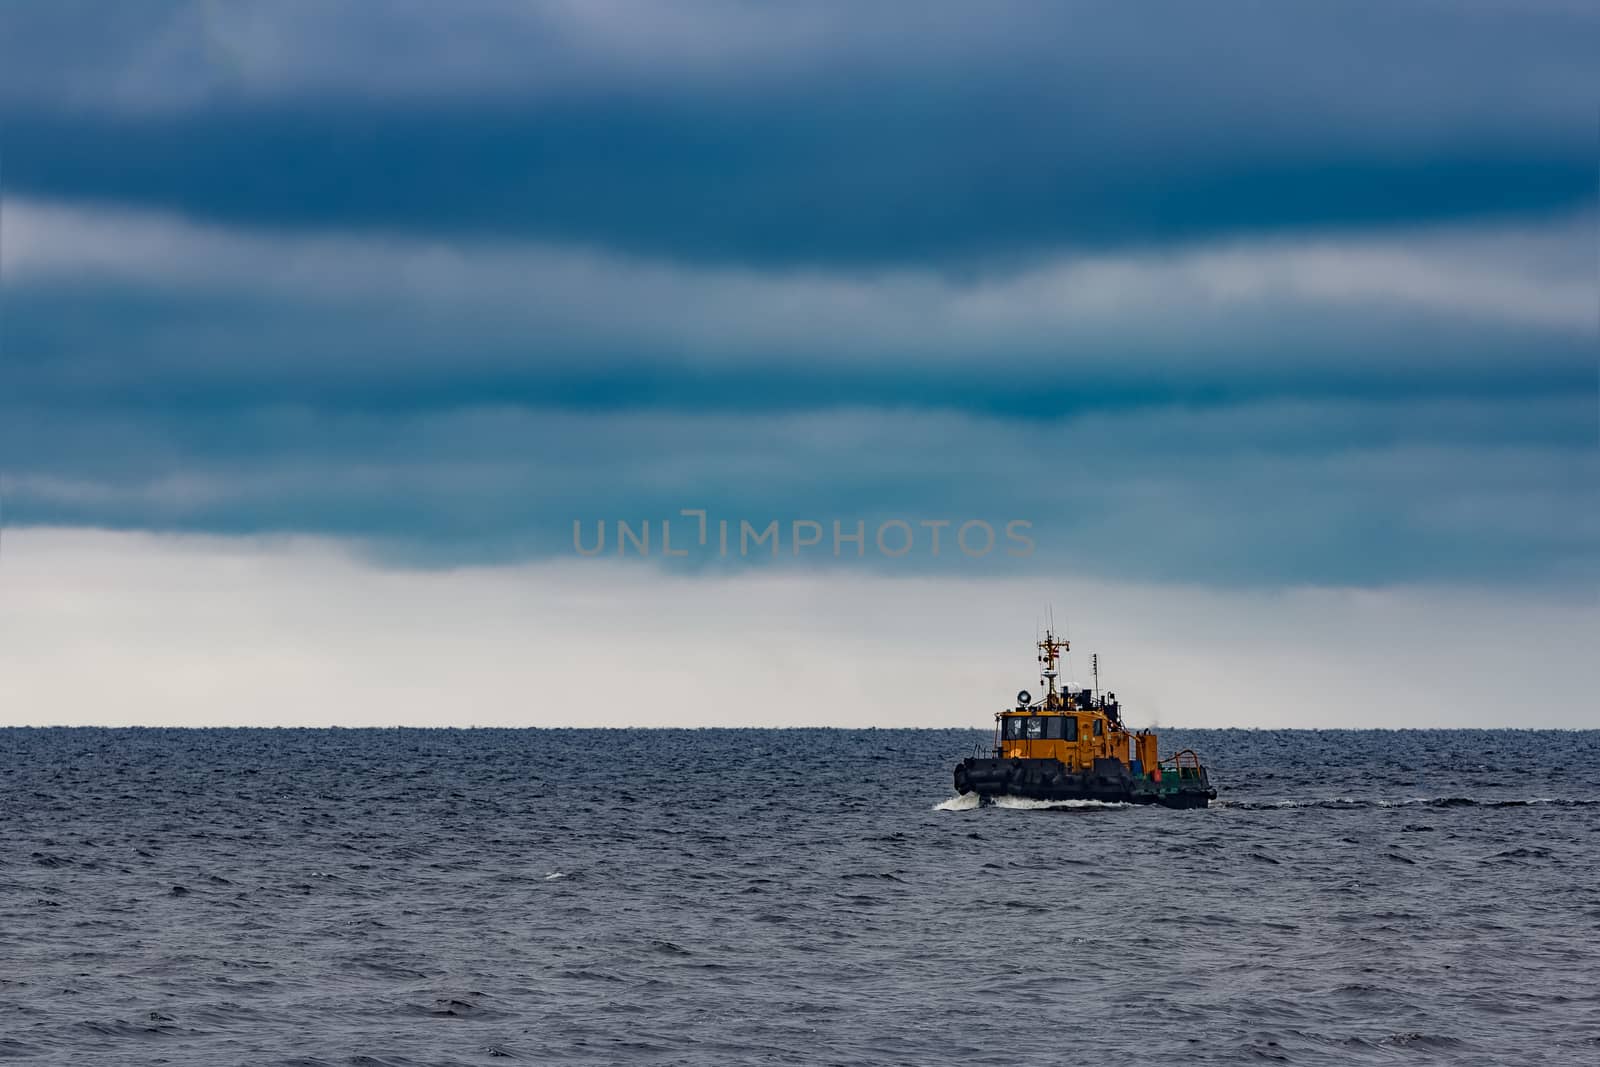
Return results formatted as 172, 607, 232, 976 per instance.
0, 2, 1600, 584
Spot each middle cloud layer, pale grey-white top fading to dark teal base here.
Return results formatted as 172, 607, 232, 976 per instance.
6, 202, 1595, 418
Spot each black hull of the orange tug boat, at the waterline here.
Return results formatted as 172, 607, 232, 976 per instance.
955, 757, 1216, 808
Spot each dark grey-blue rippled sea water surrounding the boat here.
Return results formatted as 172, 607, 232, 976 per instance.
0, 729, 1600, 1067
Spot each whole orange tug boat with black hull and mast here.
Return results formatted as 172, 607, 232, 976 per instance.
955, 630, 1216, 808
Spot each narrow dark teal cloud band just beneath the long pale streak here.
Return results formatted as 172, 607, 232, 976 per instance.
0, 279, 1594, 415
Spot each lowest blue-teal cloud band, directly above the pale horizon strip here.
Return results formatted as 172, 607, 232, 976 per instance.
3, 398, 1600, 584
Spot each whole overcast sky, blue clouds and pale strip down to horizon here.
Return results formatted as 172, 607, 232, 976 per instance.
0, 0, 1600, 726
